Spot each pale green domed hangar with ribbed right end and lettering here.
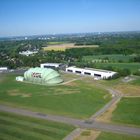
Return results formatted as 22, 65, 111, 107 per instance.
24, 67, 63, 85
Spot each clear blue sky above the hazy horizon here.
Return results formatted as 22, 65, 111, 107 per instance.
0, 0, 140, 37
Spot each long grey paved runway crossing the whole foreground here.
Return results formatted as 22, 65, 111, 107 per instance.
0, 105, 140, 136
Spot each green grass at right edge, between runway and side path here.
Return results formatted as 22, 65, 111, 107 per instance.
112, 97, 140, 125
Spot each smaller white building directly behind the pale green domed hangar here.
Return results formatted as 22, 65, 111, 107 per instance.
40, 63, 66, 70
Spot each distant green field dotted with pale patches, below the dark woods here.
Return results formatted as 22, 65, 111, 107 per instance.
83, 54, 134, 62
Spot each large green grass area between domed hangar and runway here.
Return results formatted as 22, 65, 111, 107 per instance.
0, 75, 111, 118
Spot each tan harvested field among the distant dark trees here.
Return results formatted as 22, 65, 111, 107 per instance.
43, 43, 99, 51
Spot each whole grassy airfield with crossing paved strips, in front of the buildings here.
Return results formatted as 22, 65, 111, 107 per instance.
0, 73, 140, 140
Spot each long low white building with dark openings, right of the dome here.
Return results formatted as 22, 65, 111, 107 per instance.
66, 66, 117, 79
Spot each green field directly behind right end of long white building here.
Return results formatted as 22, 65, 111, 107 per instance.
95, 63, 140, 72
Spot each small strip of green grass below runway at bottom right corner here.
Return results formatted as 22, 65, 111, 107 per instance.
96, 132, 140, 140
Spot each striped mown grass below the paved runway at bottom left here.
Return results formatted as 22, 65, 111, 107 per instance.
0, 112, 74, 140
